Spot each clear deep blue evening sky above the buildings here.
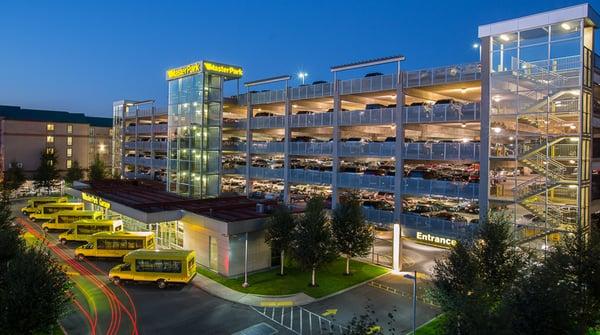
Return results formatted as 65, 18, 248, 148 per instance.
0, 0, 600, 116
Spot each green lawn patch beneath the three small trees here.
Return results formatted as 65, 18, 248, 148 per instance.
198, 258, 389, 298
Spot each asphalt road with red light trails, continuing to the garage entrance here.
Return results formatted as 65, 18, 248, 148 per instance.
14, 201, 438, 335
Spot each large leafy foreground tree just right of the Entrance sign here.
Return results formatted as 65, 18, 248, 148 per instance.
432, 213, 526, 334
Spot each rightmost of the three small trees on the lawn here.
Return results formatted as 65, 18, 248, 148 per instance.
331, 193, 375, 275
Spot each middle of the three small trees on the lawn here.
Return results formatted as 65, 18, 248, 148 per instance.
293, 197, 337, 287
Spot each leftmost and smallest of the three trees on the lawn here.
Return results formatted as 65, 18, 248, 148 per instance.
265, 206, 296, 276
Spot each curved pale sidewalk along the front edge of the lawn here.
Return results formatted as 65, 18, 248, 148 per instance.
192, 274, 316, 307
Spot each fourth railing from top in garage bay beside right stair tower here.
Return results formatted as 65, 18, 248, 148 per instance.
402, 178, 479, 199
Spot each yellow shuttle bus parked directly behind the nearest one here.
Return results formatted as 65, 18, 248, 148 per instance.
75, 231, 154, 261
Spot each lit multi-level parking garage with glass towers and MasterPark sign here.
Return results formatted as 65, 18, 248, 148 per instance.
115, 5, 600, 247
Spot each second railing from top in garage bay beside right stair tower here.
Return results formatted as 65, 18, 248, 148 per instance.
404, 103, 481, 123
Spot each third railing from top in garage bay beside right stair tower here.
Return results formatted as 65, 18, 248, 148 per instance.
404, 142, 480, 161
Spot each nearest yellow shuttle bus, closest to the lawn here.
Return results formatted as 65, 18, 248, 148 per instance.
108, 249, 196, 288
